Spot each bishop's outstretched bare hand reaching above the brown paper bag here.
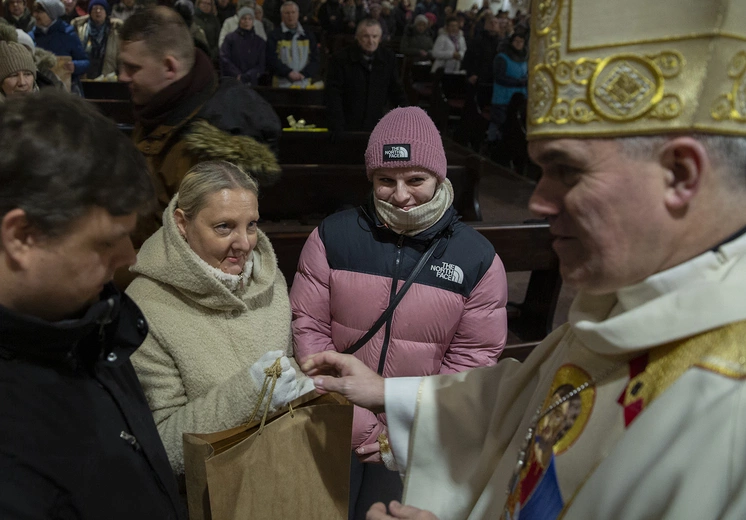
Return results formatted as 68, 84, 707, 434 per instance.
301, 351, 385, 413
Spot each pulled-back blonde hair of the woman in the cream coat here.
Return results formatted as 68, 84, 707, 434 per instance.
177, 161, 259, 220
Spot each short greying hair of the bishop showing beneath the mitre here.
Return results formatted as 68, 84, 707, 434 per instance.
615, 134, 746, 190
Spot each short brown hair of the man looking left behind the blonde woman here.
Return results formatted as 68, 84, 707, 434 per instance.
119, 6, 194, 70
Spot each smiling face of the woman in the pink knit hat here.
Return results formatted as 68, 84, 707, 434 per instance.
373, 168, 438, 211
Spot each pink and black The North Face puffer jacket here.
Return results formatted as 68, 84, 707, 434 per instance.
290, 204, 508, 458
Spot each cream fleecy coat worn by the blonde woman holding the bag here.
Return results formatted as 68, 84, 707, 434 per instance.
127, 195, 292, 475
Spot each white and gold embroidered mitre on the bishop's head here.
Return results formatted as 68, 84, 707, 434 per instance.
527, 0, 746, 139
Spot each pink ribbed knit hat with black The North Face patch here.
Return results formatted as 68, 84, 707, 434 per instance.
365, 107, 447, 182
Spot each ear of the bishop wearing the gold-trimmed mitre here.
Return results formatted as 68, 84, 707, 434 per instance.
659, 136, 712, 212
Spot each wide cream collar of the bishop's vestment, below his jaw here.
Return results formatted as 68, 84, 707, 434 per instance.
569, 235, 746, 355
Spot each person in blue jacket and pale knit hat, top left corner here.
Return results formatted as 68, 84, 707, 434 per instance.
31, 0, 90, 95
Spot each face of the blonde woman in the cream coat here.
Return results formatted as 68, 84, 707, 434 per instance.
174, 188, 259, 275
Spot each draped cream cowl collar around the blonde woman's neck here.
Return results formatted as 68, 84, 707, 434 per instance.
131, 195, 278, 311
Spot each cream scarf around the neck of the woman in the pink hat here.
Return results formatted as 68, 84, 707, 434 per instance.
373, 179, 453, 236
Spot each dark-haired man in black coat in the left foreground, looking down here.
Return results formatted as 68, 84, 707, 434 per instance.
0, 89, 186, 520
